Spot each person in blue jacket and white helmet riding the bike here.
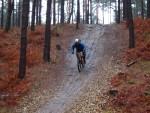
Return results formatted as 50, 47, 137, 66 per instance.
72, 38, 86, 63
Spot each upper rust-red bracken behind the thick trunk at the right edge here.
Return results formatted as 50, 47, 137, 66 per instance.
124, 18, 150, 63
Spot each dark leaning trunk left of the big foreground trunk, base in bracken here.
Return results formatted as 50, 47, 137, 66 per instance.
5, 0, 13, 32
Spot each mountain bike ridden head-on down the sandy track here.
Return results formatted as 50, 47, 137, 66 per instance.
77, 52, 85, 72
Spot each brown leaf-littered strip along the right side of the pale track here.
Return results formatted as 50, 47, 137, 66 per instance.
64, 25, 128, 113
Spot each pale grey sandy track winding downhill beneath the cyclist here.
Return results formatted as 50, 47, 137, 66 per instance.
37, 25, 104, 113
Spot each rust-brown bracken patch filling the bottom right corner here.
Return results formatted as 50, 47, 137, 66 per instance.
110, 73, 150, 113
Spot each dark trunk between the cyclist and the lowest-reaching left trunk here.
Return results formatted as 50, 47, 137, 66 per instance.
43, 0, 52, 62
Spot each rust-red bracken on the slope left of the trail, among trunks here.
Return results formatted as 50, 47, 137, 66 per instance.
0, 25, 80, 106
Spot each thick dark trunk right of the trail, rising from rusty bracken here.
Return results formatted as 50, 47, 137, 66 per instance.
126, 0, 135, 48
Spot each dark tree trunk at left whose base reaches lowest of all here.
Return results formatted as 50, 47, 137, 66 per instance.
18, 0, 30, 79
